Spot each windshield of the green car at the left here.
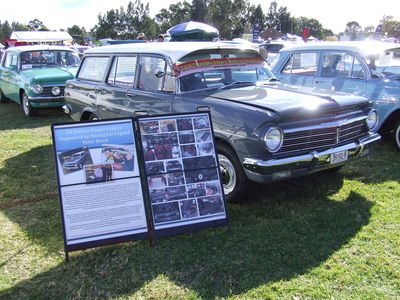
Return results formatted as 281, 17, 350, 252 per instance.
21, 50, 80, 70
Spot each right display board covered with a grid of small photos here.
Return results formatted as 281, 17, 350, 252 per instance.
138, 113, 227, 237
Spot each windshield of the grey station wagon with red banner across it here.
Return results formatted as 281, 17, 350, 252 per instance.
177, 49, 274, 92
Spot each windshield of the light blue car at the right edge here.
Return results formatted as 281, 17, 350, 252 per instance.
366, 48, 400, 76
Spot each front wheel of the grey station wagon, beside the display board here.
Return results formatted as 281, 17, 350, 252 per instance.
217, 143, 250, 203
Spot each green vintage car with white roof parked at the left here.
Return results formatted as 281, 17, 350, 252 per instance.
0, 45, 80, 117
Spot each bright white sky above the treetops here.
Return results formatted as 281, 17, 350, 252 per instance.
0, 0, 400, 33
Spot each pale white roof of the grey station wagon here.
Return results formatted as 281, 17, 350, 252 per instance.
85, 42, 257, 62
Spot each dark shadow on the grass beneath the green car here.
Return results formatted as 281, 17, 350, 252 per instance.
0, 101, 72, 130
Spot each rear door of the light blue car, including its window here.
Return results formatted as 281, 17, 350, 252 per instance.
275, 50, 319, 87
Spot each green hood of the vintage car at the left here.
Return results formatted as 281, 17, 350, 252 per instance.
21, 67, 78, 83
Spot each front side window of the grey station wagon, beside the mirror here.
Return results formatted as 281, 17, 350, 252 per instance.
138, 56, 173, 91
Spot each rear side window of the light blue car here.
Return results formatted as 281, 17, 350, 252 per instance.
282, 52, 318, 76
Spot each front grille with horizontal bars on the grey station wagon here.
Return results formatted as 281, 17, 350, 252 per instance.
279, 119, 368, 153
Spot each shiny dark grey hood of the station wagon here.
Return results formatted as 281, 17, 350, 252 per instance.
208, 85, 369, 117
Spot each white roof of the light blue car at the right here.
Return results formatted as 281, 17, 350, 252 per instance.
280, 41, 400, 56
